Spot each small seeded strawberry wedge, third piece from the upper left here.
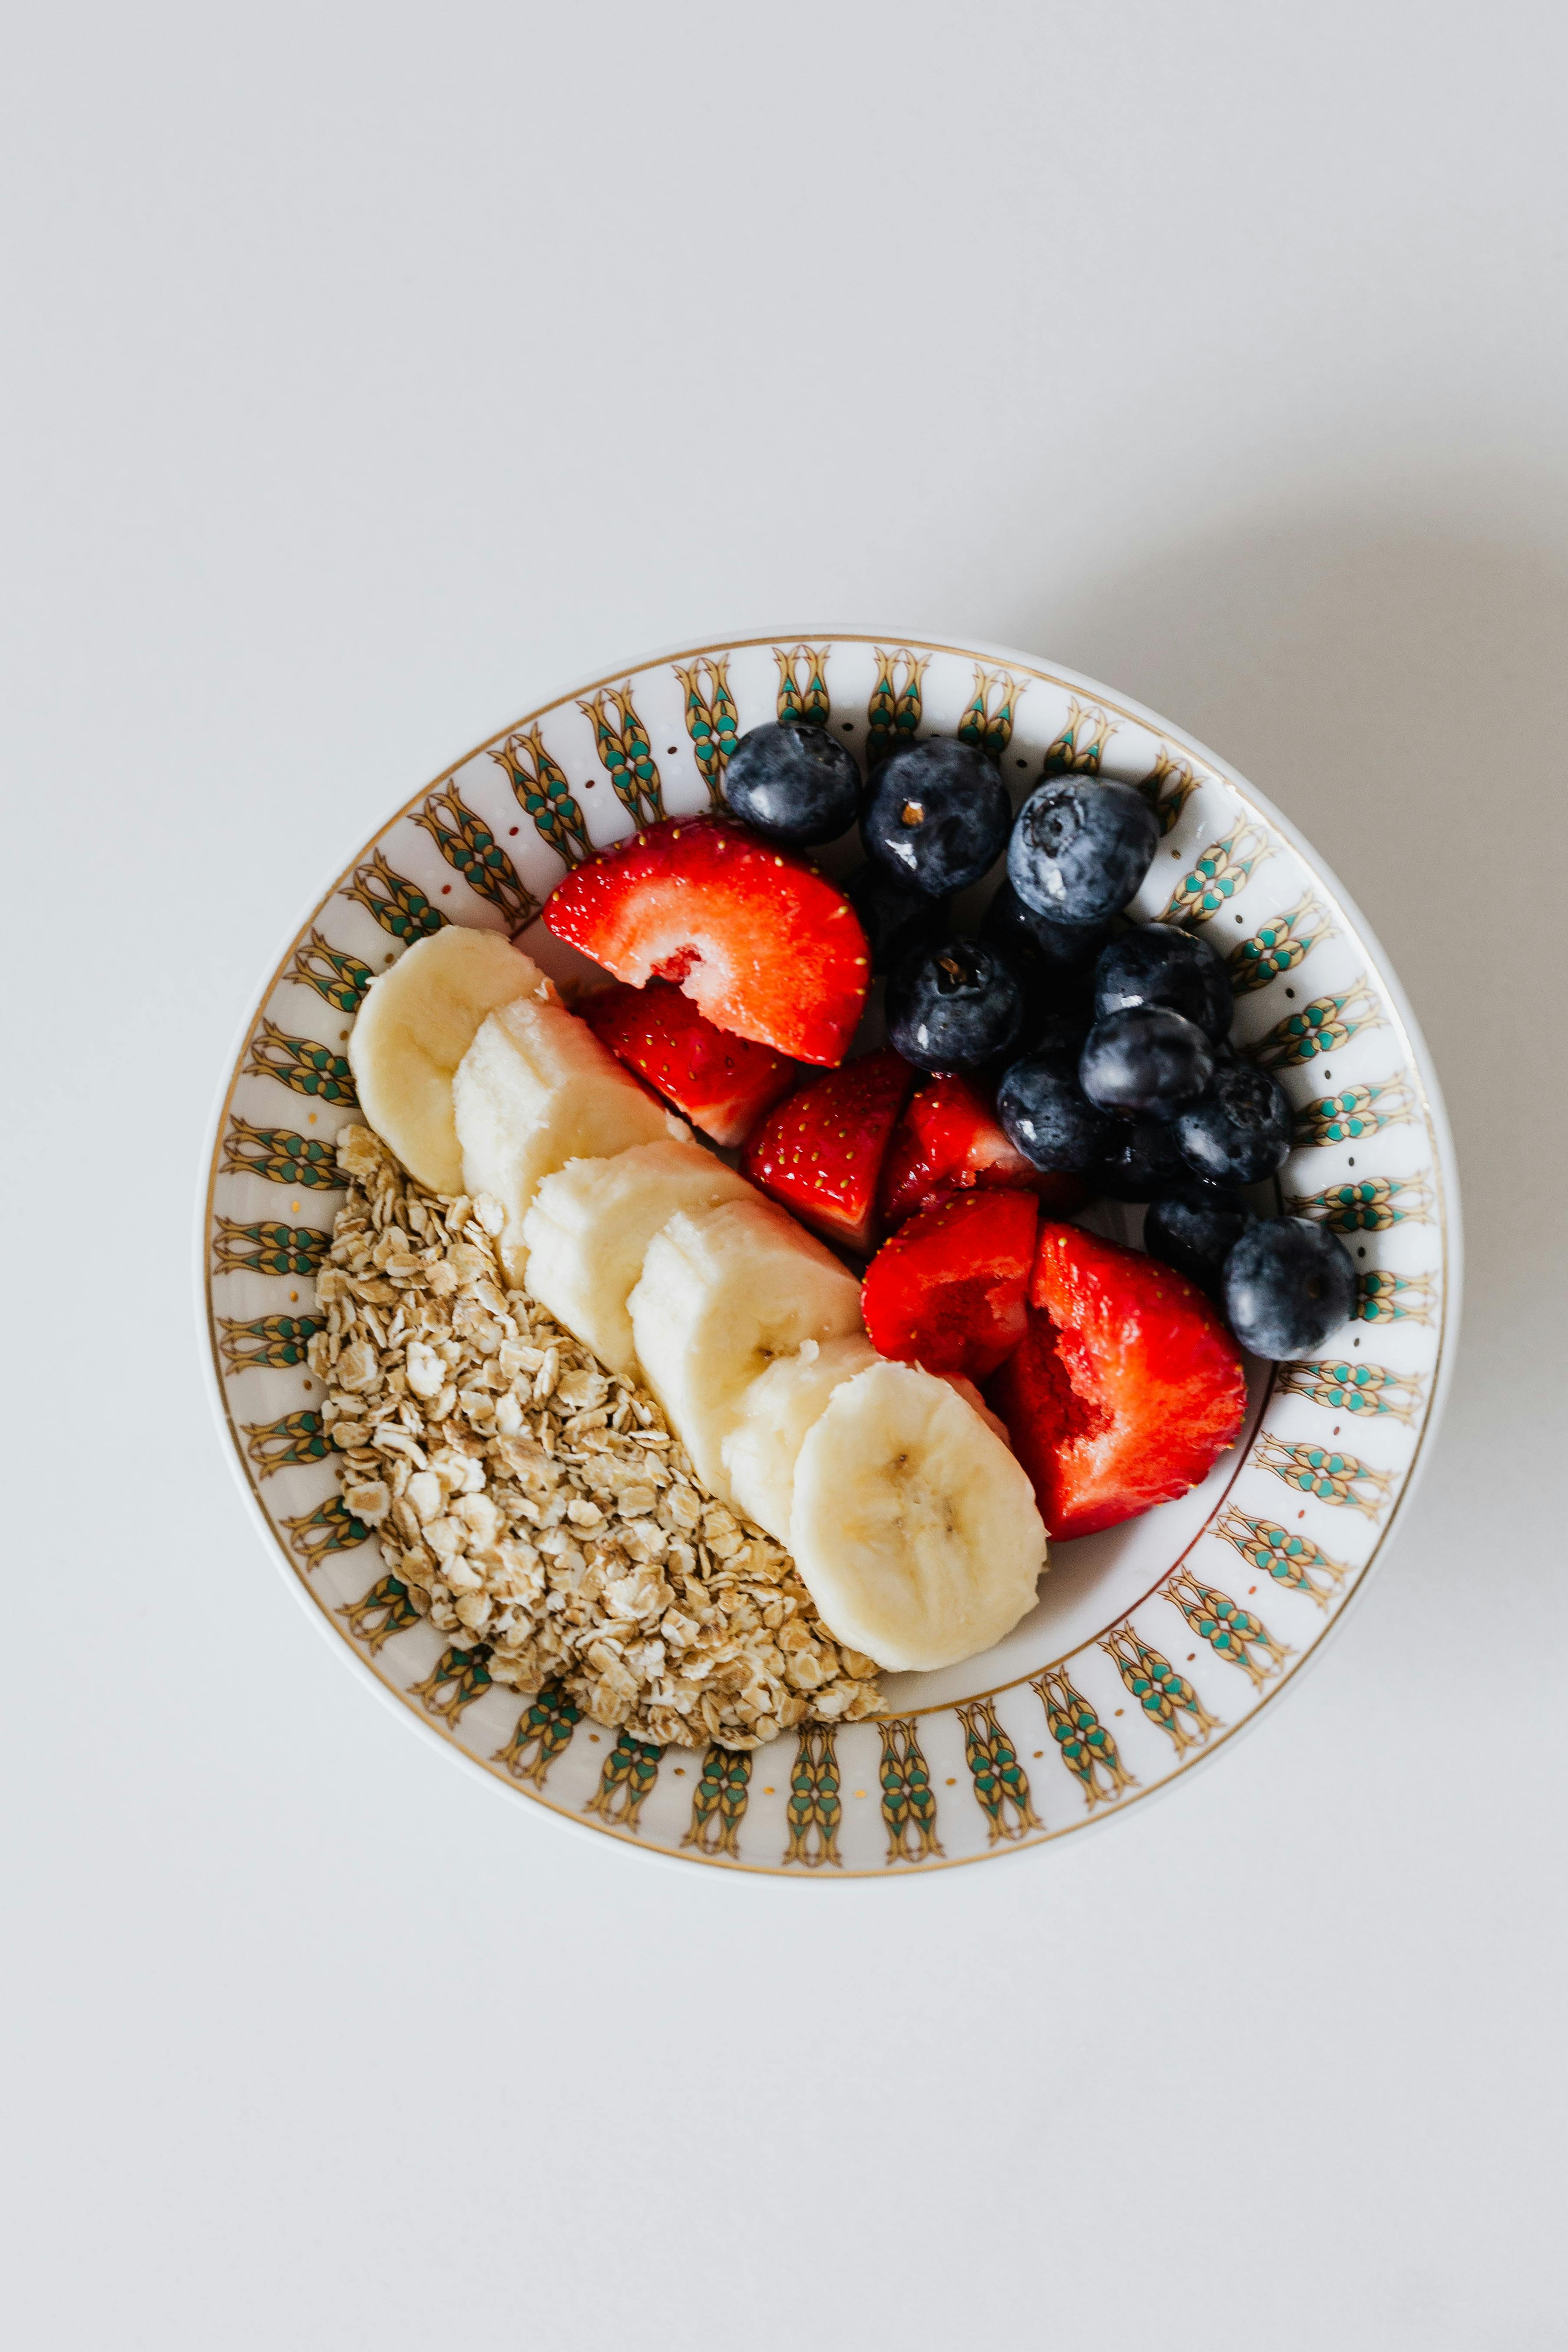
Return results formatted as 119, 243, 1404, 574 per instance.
743, 1047, 914, 1256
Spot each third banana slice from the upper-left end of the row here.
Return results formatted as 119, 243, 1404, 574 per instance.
522, 1143, 757, 1373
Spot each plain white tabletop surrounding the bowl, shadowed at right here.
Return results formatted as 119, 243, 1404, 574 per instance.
0, 0, 1568, 2352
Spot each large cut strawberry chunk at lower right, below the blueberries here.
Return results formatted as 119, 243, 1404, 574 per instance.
985, 1225, 1246, 1543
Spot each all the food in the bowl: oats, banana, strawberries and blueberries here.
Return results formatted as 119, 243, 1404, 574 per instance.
310, 720, 1354, 1747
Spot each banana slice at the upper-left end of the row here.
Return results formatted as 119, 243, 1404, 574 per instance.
348, 924, 546, 1192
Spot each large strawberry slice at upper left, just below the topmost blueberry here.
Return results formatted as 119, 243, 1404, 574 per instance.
546, 816, 872, 1065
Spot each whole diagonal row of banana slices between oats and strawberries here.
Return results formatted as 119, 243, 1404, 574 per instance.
348, 927, 1046, 1670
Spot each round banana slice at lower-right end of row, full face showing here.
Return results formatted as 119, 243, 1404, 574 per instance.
790, 1364, 1046, 1672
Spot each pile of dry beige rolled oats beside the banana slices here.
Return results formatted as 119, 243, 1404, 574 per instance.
310, 1127, 877, 1747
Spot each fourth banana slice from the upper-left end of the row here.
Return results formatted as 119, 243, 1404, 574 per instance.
628, 1197, 863, 1501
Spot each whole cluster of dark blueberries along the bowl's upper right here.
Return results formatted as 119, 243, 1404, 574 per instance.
724, 720, 1354, 1360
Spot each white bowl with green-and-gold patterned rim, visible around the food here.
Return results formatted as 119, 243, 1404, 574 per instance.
200, 630, 1460, 1882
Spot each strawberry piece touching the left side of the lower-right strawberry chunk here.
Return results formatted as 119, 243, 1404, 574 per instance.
860, 1192, 1039, 1381
